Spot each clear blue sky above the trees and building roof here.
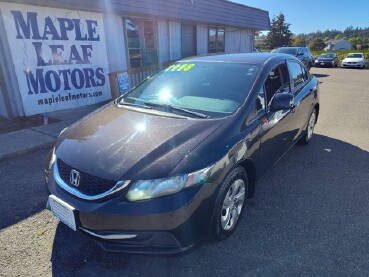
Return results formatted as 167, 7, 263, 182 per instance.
232, 0, 369, 35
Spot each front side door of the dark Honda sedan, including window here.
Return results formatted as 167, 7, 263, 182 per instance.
259, 62, 294, 175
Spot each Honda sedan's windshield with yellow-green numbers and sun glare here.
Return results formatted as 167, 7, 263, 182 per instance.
121, 61, 259, 117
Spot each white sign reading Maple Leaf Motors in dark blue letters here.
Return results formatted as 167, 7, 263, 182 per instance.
0, 3, 111, 115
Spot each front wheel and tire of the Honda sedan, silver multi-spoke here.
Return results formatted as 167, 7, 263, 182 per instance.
212, 166, 248, 241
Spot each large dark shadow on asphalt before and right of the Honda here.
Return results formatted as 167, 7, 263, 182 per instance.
51, 135, 369, 276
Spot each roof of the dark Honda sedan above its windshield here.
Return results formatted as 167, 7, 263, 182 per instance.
181, 52, 292, 64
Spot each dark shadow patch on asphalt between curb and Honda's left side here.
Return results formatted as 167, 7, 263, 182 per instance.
0, 150, 48, 230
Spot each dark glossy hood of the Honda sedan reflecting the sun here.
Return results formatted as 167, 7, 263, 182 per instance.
55, 103, 225, 181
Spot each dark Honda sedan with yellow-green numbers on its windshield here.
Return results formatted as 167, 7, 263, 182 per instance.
45, 53, 320, 253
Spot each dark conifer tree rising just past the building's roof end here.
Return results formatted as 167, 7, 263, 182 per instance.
265, 13, 292, 49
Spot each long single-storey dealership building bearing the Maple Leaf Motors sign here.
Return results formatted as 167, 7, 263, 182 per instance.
0, 0, 270, 118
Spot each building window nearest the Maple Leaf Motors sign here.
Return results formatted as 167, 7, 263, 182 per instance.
125, 19, 158, 68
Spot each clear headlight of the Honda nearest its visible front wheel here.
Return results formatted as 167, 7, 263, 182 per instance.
126, 164, 211, 201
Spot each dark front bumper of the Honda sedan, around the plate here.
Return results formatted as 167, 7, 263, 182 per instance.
47, 165, 216, 254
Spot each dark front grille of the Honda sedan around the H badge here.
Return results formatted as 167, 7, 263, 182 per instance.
57, 159, 117, 196
